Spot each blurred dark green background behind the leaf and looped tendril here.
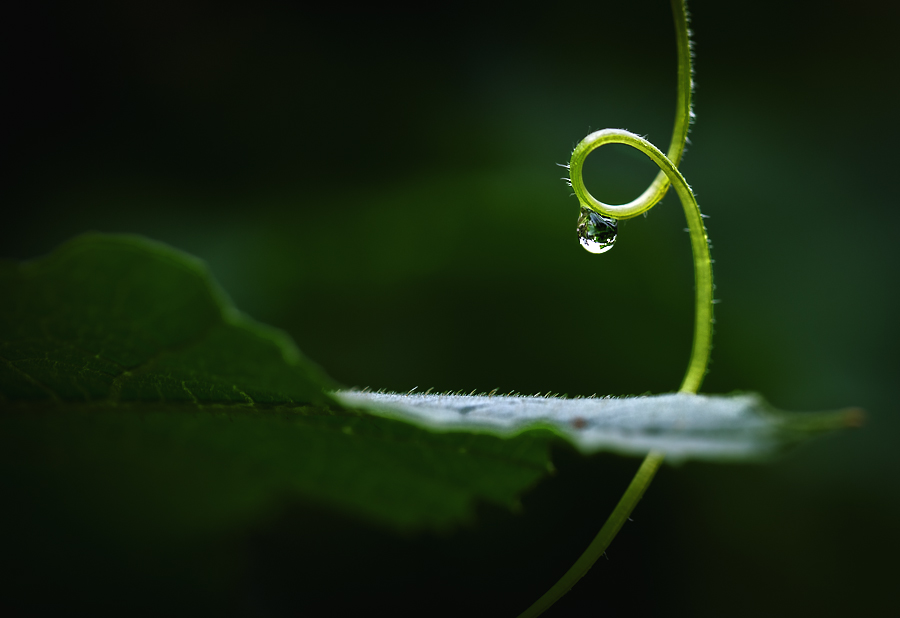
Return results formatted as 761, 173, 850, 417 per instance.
0, 0, 900, 616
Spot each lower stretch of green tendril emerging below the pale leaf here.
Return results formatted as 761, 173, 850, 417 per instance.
519, 453, 663, 618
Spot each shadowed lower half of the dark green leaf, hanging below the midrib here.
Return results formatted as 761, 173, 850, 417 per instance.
0, 402, 550, 534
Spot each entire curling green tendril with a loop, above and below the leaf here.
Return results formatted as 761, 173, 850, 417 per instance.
519, 0, 713, 618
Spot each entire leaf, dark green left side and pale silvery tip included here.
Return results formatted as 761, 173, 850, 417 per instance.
0, 235, 850, 538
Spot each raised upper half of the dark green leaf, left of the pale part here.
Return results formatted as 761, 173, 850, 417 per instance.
0, 234, 334, 404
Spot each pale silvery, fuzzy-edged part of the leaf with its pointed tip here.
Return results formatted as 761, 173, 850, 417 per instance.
334, 391, 860, 463
